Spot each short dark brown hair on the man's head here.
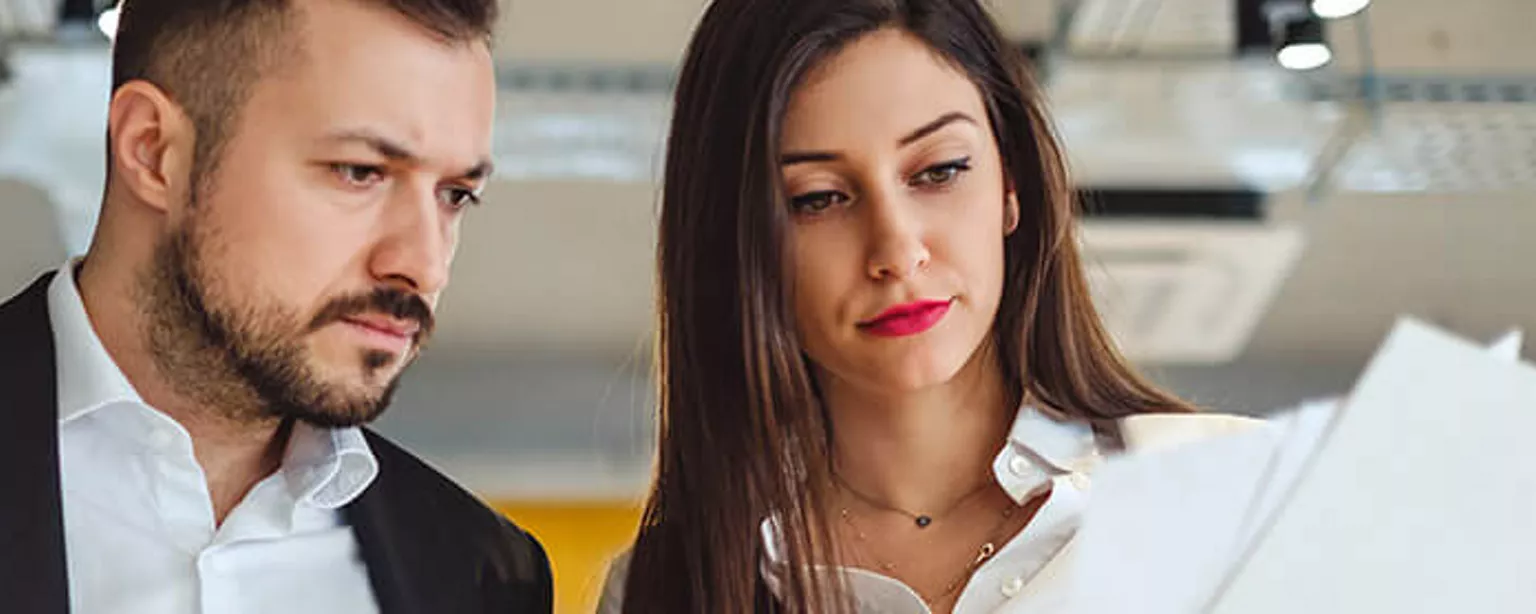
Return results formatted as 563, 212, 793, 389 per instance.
112, 0, 498, 184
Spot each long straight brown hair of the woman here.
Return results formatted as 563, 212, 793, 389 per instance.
624, 0, 1189, 614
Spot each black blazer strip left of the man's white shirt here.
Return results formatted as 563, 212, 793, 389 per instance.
0, 275, 69, 614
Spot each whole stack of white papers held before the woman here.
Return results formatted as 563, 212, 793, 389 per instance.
1072, 321, 1536, 614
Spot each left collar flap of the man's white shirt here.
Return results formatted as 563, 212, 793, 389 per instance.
48, 258, 143, 424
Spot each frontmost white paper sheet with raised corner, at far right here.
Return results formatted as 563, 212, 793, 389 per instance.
1209, 321, 1536, 614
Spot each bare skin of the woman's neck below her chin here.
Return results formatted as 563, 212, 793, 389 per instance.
822, 345, 1015, 513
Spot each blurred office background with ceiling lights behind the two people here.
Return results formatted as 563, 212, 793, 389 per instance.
0, 0, 1536, 612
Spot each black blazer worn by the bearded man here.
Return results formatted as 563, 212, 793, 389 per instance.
0, 275, 553, 614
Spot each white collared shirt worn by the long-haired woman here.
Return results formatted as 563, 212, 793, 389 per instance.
599, 407, 1250, 614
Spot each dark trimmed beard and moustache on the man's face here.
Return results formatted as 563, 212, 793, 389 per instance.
140, 212, 433, 428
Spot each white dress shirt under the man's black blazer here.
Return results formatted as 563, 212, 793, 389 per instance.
48, 262, 378, 614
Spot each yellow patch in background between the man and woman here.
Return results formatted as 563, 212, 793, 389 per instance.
493, 500, 641, 614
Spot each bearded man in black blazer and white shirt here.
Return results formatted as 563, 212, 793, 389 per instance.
0, 0, 551, 614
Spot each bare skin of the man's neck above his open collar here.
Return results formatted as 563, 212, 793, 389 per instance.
66, 258, 292, 525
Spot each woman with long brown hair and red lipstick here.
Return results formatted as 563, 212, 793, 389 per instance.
602, 0, 1247, 614
